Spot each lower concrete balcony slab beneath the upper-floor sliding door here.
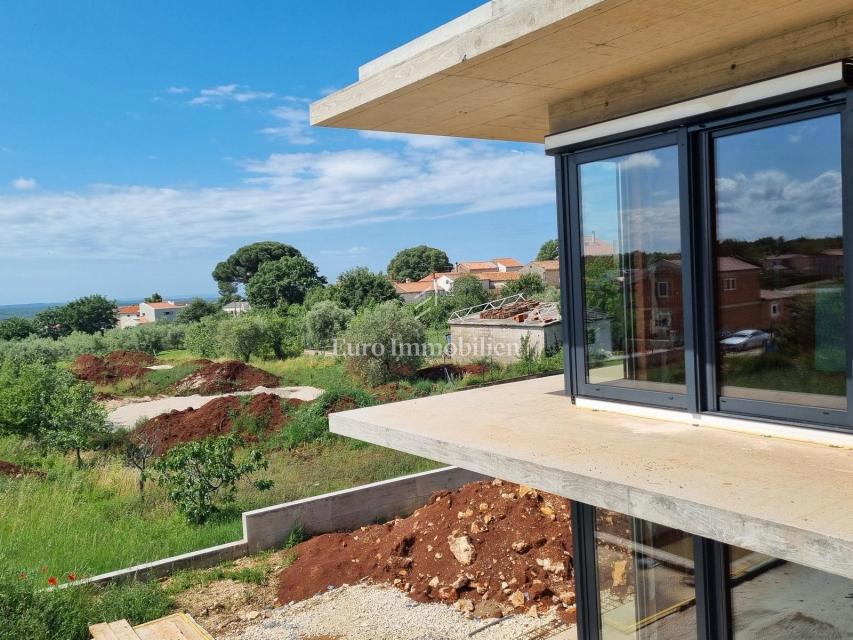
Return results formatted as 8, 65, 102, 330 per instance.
329, 376, 853, 578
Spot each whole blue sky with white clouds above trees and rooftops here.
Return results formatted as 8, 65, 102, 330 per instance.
0, 0, 556, 304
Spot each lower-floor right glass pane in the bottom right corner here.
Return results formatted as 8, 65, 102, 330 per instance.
729, 547, 853, 640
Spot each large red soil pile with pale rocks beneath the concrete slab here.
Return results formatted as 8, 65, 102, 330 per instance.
278, 480, 575, 621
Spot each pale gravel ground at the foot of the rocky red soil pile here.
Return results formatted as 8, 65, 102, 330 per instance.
228, 584, 576, 640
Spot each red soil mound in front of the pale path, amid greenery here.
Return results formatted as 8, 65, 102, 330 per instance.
132, 393, 302, 456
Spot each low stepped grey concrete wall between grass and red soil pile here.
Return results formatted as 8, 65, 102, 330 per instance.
74, 467, 484, 585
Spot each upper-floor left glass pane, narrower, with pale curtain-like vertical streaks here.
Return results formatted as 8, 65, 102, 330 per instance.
579, 147, 685, 393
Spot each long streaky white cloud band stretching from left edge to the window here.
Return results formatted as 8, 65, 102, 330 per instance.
0, 143, 554, 259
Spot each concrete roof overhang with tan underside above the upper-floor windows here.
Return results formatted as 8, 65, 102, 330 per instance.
311, 0, 853, 143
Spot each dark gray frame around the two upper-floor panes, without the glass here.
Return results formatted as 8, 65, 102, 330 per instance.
551, 87, 853, 431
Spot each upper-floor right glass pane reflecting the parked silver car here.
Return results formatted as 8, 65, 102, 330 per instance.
715, 115, 847, 410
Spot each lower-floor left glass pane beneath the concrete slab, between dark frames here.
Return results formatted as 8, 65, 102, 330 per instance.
595, 509, 696, 640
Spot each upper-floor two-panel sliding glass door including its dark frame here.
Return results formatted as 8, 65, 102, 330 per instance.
561, 94, 853, 429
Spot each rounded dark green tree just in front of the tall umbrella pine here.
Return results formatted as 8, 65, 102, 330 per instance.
246, 254, 326, 309
